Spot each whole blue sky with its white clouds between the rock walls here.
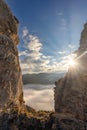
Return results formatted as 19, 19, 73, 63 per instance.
6, 0, 87, 74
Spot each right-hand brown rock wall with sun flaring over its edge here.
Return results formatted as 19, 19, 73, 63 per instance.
54, 24, 87, 130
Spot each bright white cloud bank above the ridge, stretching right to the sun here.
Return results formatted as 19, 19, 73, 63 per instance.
19, 27, 76, 74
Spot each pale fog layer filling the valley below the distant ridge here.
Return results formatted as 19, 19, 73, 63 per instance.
24, 84, 55, 110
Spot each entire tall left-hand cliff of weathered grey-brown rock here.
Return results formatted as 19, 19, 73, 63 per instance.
0, 0, 23, 111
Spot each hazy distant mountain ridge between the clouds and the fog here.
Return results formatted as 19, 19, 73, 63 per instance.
22, 72, 65, 84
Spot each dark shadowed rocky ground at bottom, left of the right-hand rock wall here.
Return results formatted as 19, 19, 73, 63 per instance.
0, 113, 53, 130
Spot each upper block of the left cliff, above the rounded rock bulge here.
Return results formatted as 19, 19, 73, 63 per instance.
0, 0, 19, 44
